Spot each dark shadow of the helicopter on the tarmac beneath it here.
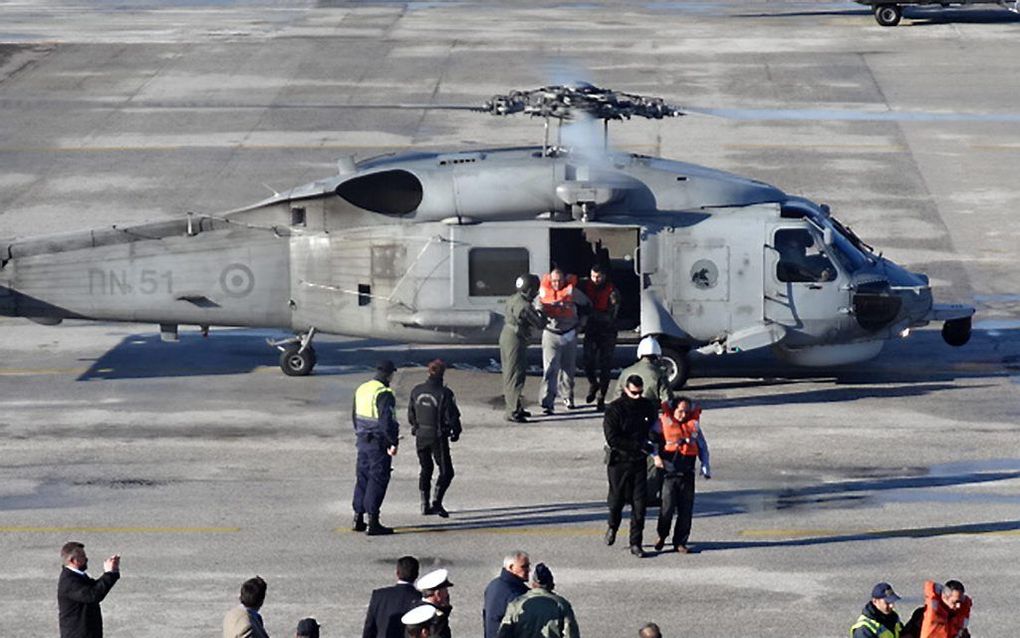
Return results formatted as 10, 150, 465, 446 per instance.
79, 328, 1020, 389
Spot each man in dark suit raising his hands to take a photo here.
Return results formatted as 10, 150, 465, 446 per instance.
57, 541, 120, 638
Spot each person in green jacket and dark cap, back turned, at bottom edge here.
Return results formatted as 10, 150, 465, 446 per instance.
496, 562, 580, 638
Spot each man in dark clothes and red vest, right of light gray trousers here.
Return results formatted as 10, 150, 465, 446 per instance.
578, 263, 620, 412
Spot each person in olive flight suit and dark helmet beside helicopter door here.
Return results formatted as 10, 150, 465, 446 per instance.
500, 274, 546, 423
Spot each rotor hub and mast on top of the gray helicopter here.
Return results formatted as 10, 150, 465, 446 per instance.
479, 82, 686, 152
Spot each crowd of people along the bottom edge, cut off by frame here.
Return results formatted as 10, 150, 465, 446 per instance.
57, 541, 972, 638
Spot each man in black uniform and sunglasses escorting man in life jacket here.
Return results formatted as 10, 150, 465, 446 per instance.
602, 375, 659, 558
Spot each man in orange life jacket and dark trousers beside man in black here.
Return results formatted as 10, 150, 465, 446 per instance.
652, 396, 712, 554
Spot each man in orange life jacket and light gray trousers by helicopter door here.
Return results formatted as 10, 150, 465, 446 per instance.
534, 268, 591, 414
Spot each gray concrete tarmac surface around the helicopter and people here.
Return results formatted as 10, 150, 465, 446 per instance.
0, 0, 1020, 638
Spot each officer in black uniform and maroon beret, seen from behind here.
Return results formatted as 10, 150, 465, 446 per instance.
407, 359, 460, 519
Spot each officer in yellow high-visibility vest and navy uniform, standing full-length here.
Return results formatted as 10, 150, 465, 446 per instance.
352, 360, 400, 536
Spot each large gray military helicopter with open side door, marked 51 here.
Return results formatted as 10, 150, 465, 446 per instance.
0, 84, 974, 387
